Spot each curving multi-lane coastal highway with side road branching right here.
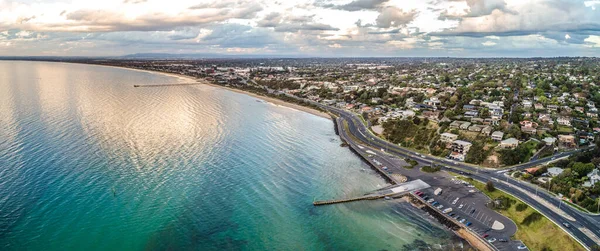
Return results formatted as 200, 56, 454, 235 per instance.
324, 103, 600, 249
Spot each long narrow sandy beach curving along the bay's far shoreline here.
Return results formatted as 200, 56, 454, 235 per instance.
110, 66, 331, 119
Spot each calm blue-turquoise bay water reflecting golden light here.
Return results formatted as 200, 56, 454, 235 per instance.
0, 61, 456, 250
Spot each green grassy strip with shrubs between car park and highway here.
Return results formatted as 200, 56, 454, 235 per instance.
457, 176, 585, 251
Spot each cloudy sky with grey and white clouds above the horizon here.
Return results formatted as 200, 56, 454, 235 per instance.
0, 0, 600, 57
